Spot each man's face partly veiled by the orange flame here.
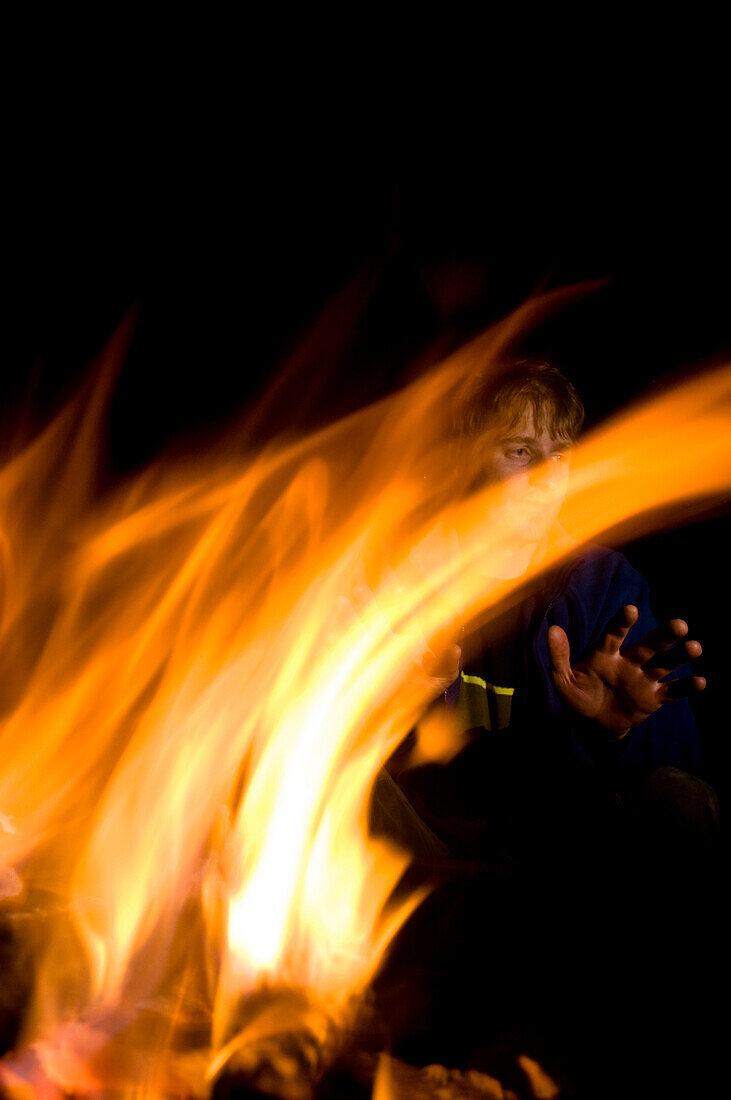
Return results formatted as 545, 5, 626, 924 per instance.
480, 414, 572, 549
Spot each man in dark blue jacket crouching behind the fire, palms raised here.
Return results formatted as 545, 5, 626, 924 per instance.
400, 360, 712, 862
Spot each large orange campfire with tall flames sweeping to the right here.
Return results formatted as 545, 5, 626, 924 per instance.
0, 294, 731, 1100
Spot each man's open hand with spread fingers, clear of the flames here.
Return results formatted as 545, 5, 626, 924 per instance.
549, 604, 706, 740
